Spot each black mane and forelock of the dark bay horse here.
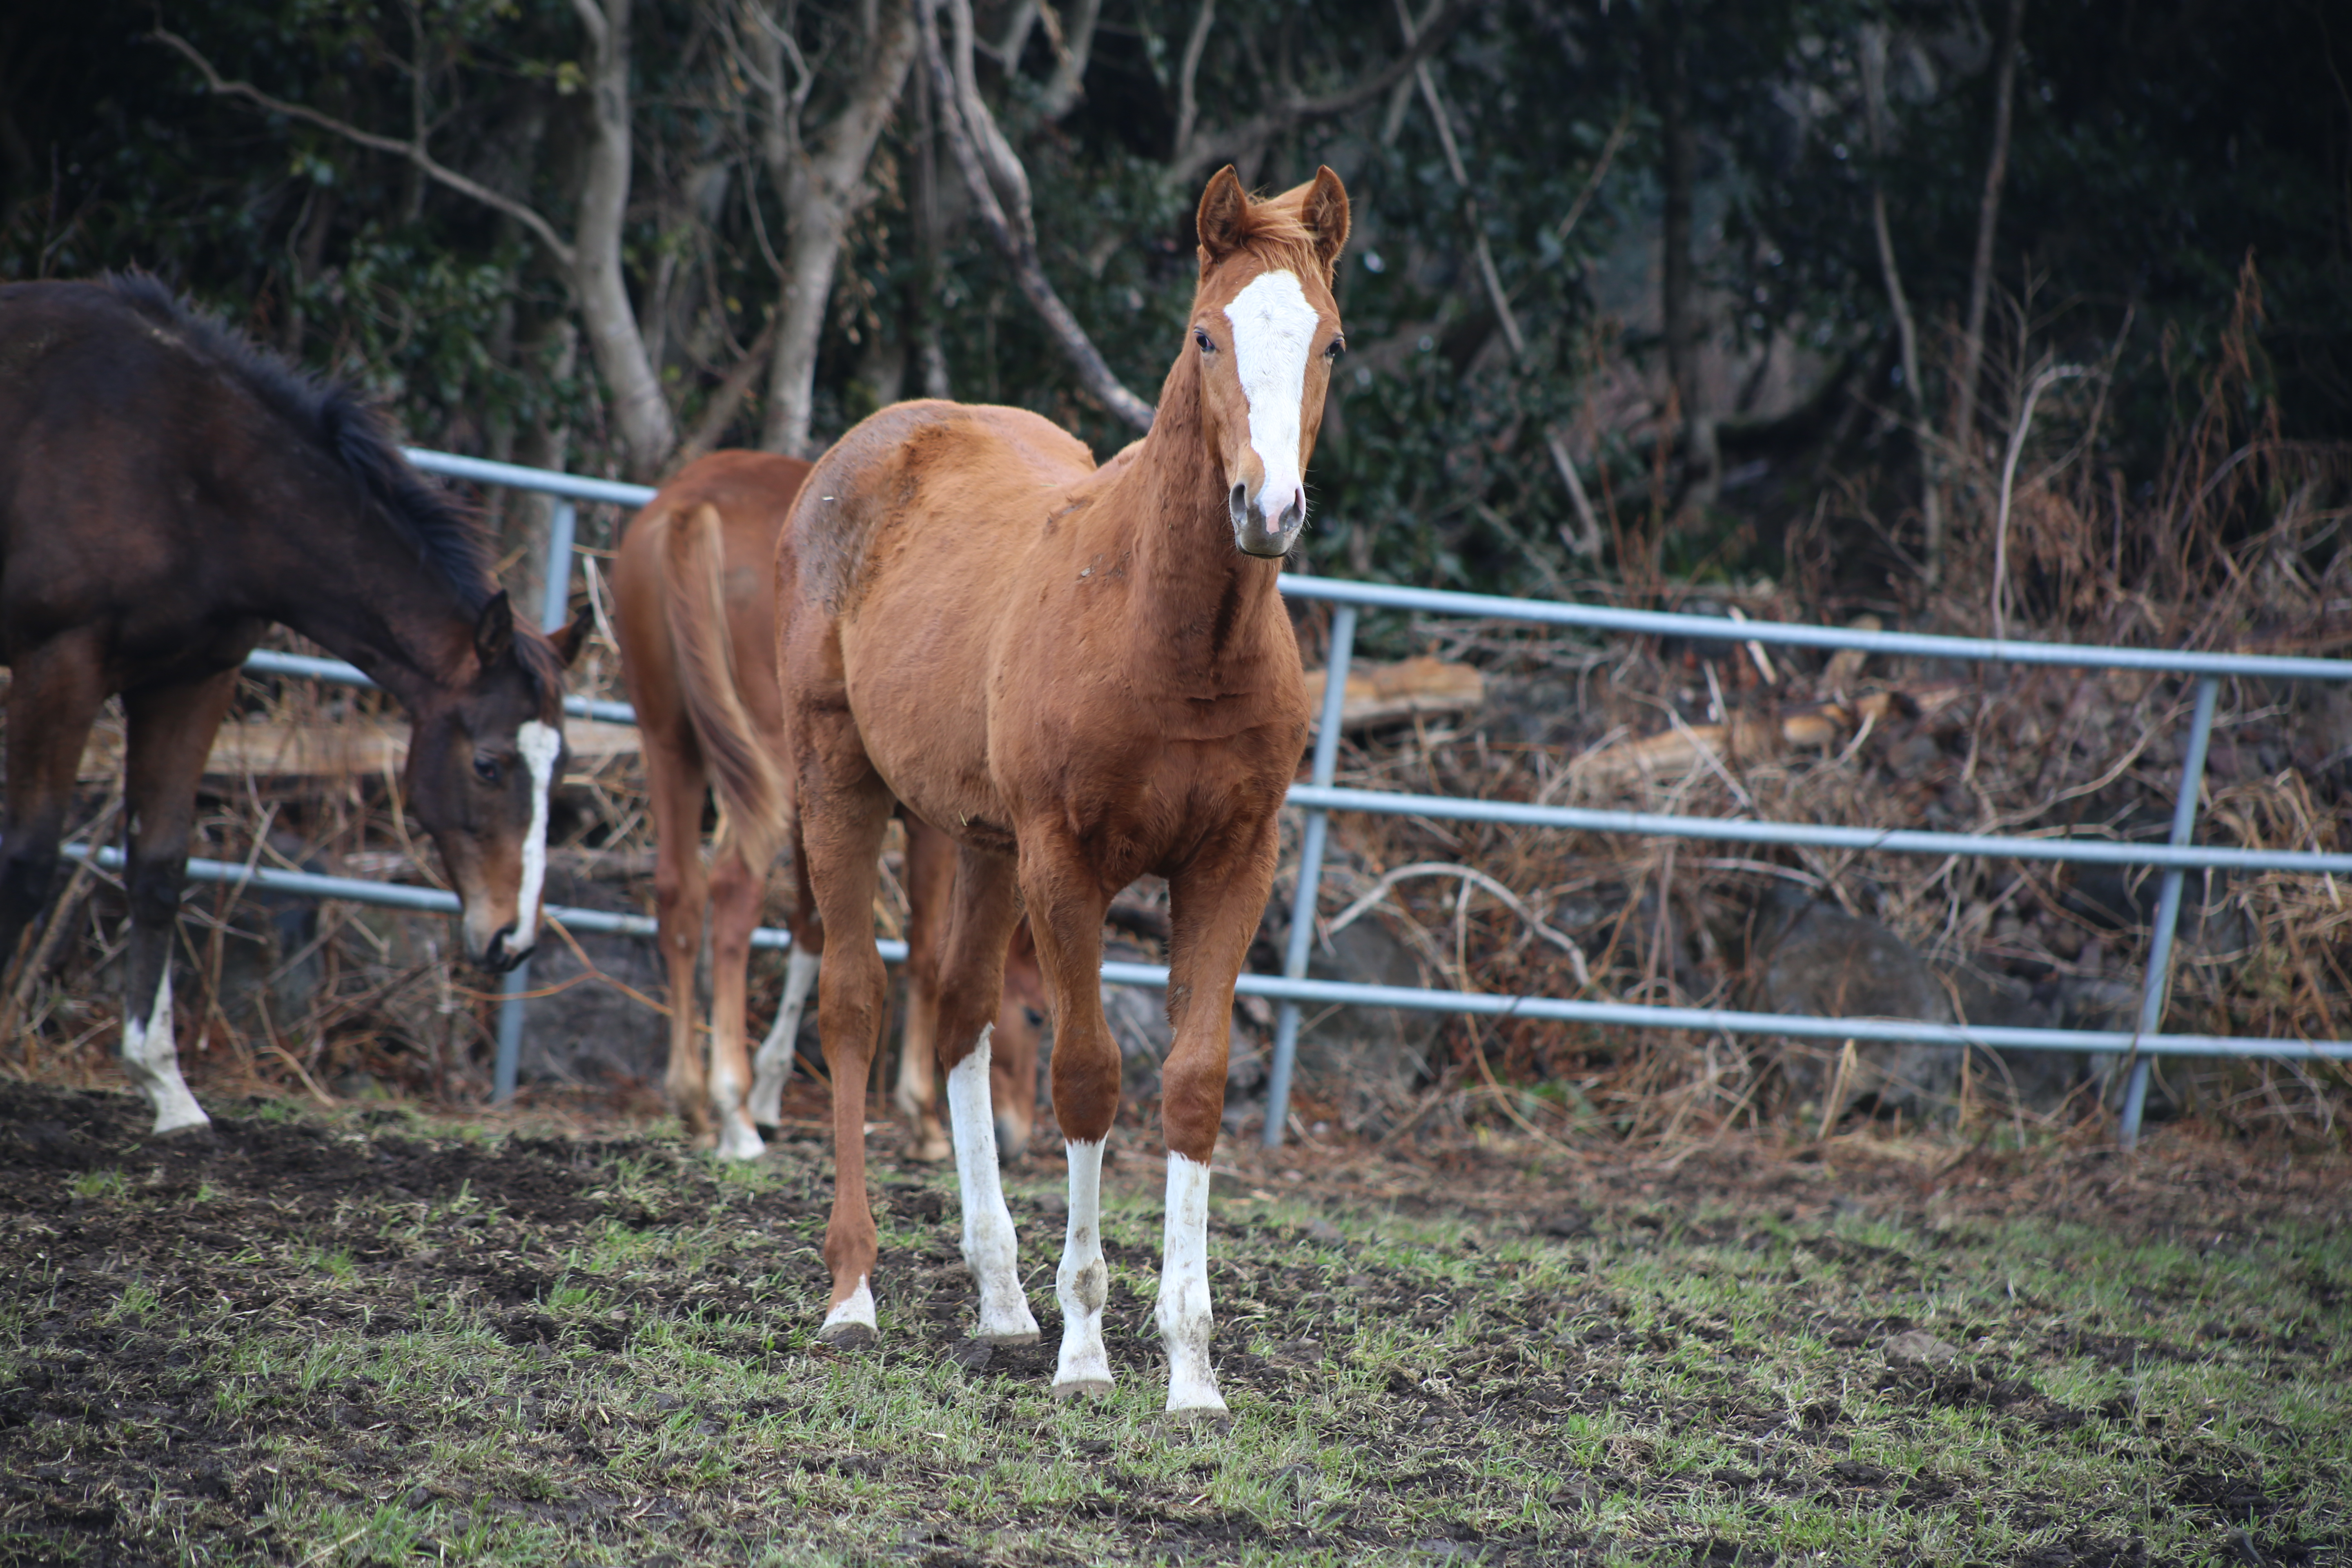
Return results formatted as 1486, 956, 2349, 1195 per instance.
103, 273, 562, 696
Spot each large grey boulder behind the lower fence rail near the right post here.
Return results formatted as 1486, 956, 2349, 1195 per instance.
1748, 889, 1959, 1117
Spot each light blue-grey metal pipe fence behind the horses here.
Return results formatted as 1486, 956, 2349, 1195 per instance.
178, 449, 2352, 1147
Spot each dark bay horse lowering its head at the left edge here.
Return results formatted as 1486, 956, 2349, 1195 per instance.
0, 277, 581, 1133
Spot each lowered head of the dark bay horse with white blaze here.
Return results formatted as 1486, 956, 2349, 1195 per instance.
407, 592, 586, 973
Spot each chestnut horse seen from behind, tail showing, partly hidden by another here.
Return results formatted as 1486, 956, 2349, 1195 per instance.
612, 451, 1042, 1159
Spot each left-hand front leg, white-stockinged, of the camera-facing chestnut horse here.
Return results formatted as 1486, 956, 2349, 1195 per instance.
1021, 835, 1120, 1399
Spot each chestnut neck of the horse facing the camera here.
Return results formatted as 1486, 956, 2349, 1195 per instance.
1105, 355, 1282, 675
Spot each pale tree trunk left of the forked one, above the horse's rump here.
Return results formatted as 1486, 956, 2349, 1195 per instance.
572, 0, 677, 477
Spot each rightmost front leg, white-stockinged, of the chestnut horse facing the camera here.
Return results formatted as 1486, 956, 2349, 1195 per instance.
1155, 818, 1275, 1415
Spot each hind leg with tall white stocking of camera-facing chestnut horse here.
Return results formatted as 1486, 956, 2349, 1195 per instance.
910, 849, 1037, 1345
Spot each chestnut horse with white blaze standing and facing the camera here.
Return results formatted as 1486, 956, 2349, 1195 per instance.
776, 169, 1348, 1413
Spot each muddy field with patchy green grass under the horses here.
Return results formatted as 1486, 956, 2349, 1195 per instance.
0, 1084, 2352, 1568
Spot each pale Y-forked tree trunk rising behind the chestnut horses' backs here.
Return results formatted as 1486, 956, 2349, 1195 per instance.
760, 0, 915, 456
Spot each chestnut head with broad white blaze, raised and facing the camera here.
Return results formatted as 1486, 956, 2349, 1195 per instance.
1190, 167, 1348, 555
